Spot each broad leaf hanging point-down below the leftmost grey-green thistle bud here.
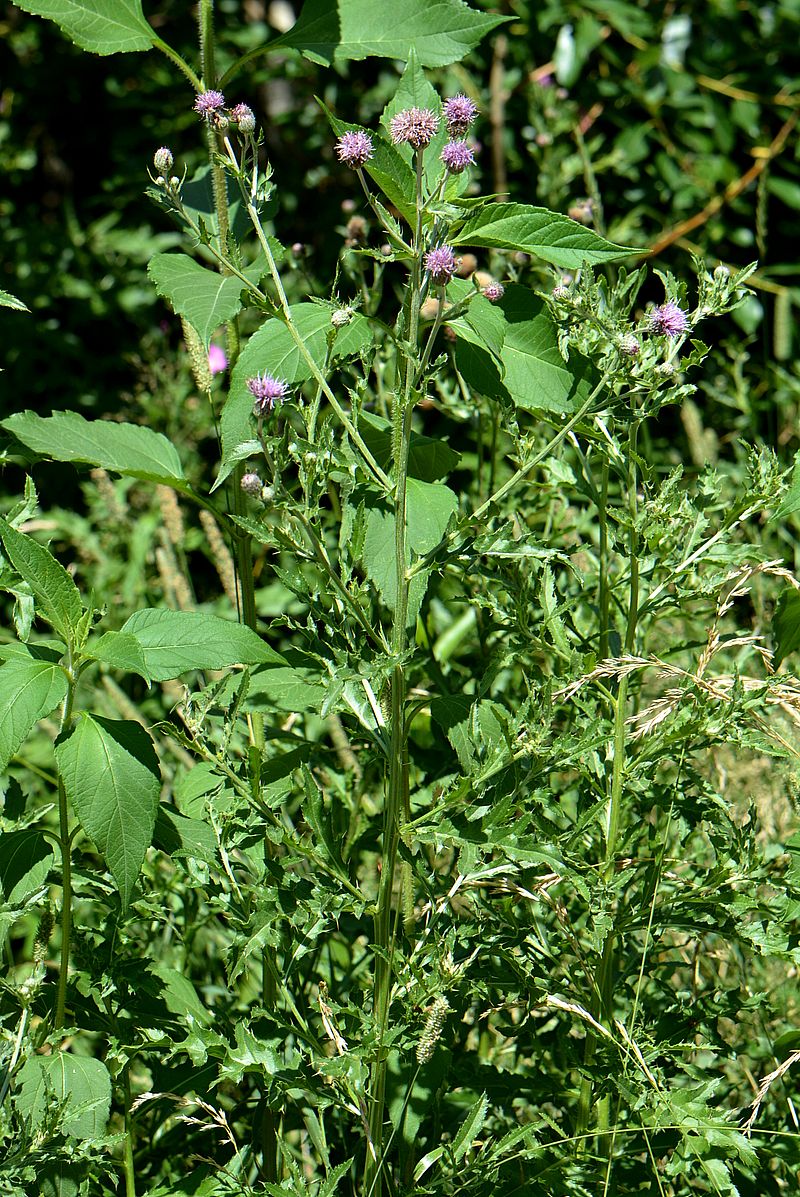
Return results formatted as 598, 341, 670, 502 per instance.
147, 254, 267, 350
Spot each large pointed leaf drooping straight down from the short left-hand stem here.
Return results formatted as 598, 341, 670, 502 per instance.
55, 712, 160, 906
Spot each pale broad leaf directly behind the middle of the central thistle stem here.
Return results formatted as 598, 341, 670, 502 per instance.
362, 478, 459, 624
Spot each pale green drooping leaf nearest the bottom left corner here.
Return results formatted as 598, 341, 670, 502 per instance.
14, 1051, 111, 1138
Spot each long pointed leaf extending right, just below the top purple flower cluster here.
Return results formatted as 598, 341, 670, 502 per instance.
450, 203, 641, 271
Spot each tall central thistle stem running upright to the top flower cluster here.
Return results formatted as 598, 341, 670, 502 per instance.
364, 151, 423, 1197
